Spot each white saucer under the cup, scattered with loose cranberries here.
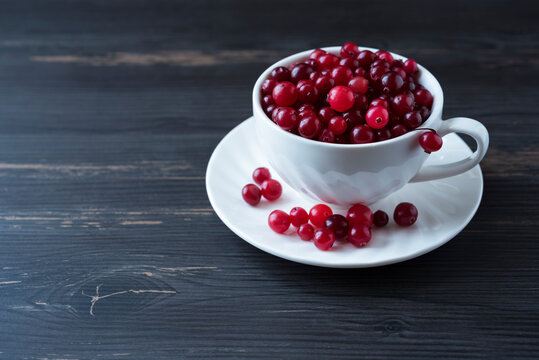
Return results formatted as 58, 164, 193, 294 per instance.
206, 117, 483, 268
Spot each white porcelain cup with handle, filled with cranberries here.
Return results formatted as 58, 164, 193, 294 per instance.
253, 46, 489, 206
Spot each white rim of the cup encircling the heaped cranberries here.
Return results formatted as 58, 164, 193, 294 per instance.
252, 46, 444, 149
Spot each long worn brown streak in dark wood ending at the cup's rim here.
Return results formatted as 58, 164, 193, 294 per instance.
30, 50, 279, 66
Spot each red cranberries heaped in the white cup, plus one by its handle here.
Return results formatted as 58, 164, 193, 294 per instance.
261, 42, 434, 143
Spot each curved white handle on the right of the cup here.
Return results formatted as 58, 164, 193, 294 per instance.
410, 117, 488, 182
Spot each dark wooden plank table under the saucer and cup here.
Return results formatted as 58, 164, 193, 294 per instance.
0, 0, 539, 359
